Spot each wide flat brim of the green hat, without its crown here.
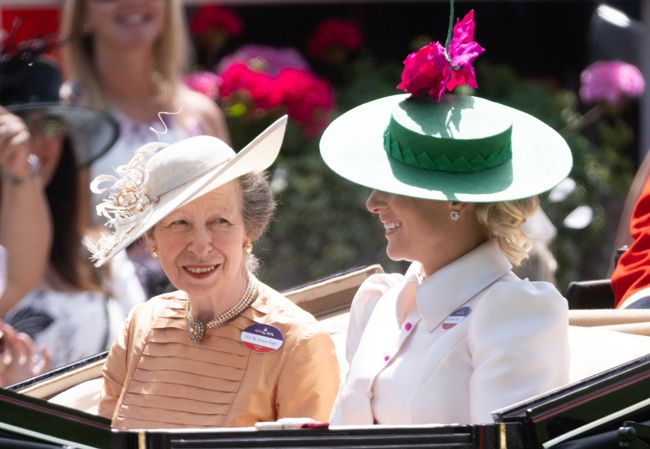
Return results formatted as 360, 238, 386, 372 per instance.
320, 95, 572, 202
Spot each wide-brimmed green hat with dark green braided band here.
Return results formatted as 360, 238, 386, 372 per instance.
320, 94, 572, 203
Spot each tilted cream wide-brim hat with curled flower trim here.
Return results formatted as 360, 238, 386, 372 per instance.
86, 116, 287, 266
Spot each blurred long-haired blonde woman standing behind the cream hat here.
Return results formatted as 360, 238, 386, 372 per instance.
61, 0, 229, 224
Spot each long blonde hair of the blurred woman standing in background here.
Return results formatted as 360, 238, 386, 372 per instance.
61, 0, 191, 109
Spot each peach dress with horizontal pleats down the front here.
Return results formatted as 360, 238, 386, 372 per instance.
99, 283, 339, 429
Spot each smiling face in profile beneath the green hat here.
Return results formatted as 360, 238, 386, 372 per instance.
366, 190, 485, 274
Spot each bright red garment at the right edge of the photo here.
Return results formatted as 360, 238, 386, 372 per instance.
611, 178, 650, 307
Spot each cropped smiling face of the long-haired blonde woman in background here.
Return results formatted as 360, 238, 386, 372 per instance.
85, 0, 170, 48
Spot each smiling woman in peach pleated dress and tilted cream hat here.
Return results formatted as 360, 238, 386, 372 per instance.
93, 118, 338, 429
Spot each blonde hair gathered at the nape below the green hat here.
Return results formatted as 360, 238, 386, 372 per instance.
476, 196, 539, 266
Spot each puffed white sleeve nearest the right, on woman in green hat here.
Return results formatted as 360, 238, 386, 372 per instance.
468, 280, 570, 423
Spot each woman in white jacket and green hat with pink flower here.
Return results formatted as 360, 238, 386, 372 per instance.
321, 11, 571, 424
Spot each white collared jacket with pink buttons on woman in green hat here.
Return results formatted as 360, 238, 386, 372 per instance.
330, 241, 569, 425
